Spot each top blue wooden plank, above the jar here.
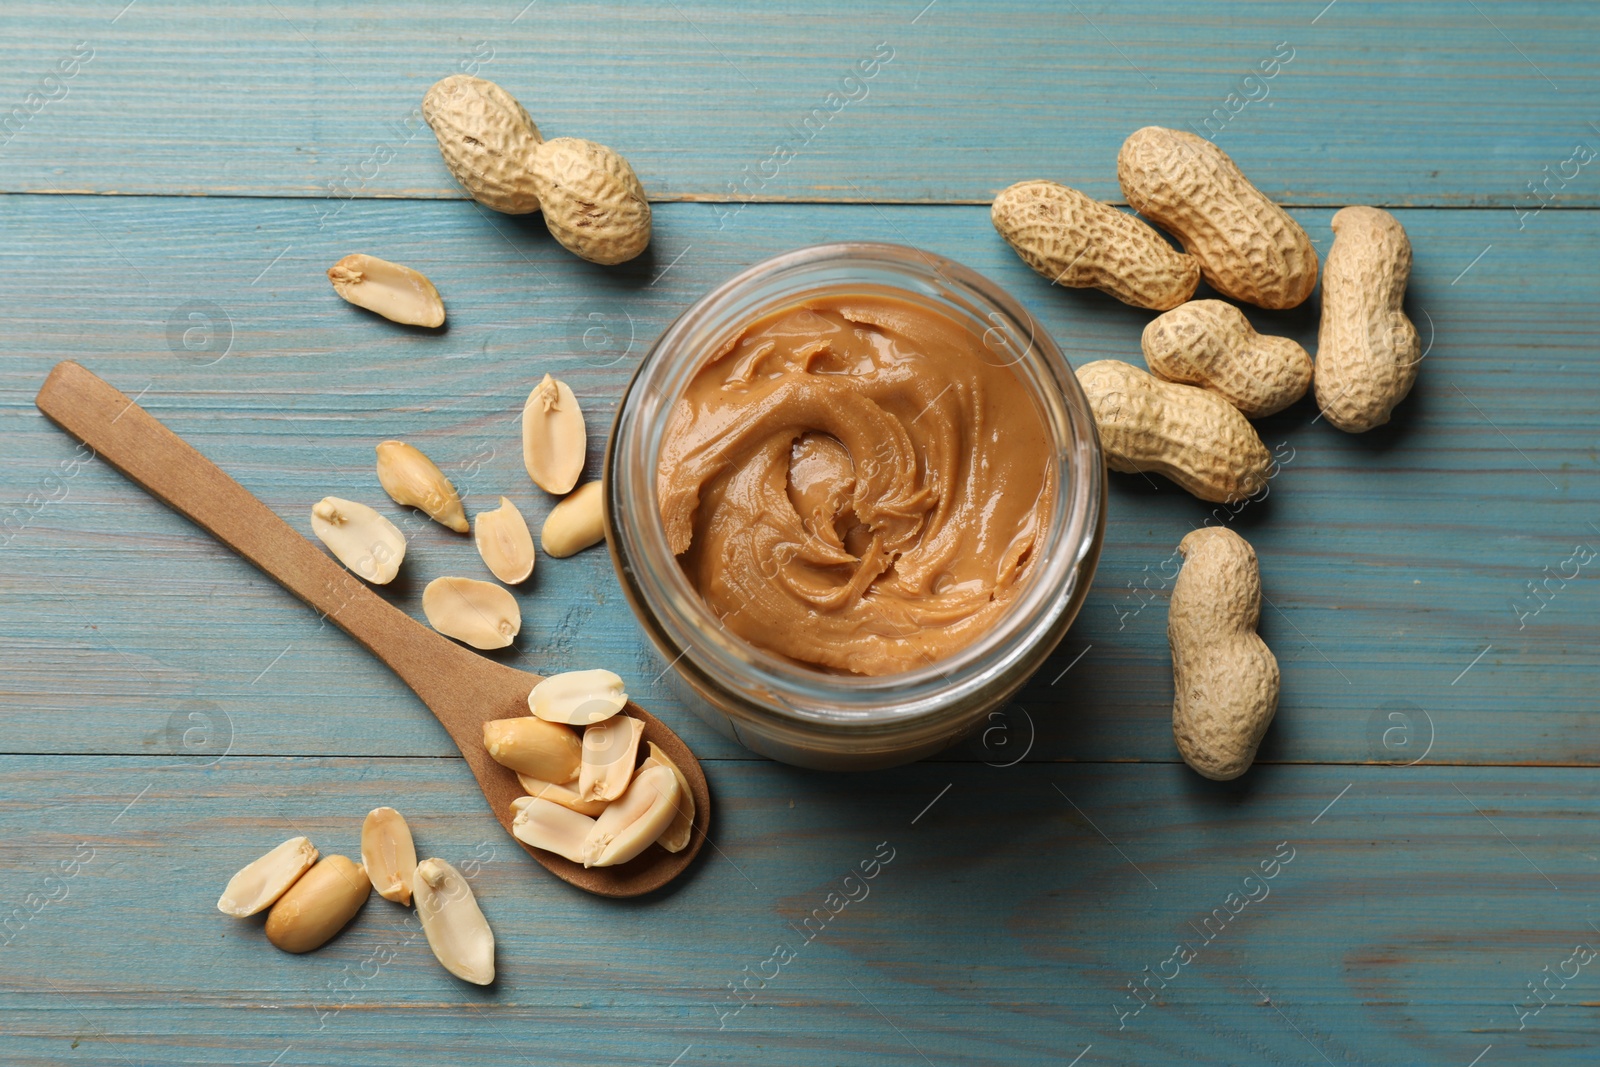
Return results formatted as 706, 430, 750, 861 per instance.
0, 0, 1600, 204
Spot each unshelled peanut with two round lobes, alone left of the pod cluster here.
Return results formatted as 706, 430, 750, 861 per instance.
422, 74, 650, 266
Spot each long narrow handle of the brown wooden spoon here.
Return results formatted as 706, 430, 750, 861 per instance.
35, 360, 475, 707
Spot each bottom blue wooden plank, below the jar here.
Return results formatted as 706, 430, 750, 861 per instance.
0, 757, 1600, 1067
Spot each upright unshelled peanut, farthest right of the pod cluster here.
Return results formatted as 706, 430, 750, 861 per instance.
1317, 206, 1422, 434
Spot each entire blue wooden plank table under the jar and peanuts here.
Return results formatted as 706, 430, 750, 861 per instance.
0, 0, 1600, 1067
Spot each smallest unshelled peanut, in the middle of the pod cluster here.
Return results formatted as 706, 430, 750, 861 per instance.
1139, 301, 1312, 419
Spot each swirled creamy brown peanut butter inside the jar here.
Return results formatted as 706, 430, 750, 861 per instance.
656, 291, 1056, 675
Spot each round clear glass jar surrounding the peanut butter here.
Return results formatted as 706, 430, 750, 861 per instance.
605, 243, 1106, 769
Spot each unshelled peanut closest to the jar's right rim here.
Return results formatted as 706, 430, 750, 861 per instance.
1077, 360, 1272, 502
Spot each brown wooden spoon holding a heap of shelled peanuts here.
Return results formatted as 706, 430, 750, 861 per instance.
35, 360, 710, 897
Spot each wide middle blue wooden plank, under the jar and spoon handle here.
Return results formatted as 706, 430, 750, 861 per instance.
0, 197, 1600, 765
